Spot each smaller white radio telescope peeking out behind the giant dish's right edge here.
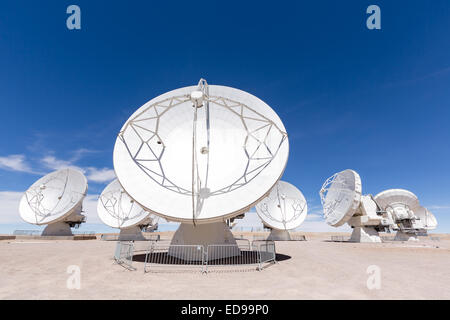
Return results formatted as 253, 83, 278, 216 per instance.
256, 181, 308, 240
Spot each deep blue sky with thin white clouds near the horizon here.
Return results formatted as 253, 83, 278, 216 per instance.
0, 0, 450, 232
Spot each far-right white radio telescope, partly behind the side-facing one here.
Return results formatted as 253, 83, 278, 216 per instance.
375, 189, 437, 241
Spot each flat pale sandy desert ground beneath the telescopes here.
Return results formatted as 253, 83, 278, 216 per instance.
0, 233, 450, 299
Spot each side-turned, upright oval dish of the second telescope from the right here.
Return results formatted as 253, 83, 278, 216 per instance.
320, 169, 362, 227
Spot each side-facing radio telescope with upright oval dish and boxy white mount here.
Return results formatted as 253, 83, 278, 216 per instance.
320, 169, 392, 242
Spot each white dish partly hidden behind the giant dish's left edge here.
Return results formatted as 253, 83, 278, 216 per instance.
97, 179, 153, 229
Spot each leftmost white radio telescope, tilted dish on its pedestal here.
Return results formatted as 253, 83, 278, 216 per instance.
19, 168, 88, 236
